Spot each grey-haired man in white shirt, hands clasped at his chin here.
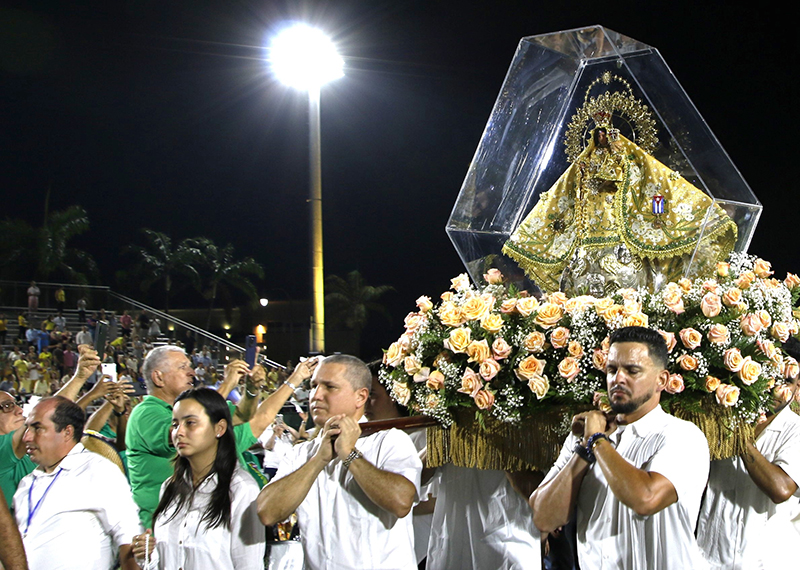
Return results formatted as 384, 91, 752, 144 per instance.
258, 355, 422, 570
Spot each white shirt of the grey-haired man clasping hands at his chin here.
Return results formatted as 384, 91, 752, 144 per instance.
275, 429, 422, 570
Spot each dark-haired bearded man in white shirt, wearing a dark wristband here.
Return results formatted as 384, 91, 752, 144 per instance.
530, 327, 709, 570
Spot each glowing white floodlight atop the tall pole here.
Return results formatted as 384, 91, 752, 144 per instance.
270, 24, 344, 90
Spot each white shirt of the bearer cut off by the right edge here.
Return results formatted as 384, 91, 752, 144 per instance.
697, 406, 800, 570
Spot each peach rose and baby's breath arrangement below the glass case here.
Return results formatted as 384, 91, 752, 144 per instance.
379, 253, 800, 427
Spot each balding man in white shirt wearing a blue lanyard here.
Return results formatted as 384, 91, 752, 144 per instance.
14, 396, 140, 570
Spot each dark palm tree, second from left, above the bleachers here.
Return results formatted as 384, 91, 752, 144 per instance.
125, 228, 203, 313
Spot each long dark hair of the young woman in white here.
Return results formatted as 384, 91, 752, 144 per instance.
153, 388, 238, 529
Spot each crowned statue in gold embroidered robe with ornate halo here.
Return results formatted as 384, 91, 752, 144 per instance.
503, 73, 737, 296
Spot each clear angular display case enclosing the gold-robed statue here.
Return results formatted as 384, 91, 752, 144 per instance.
446, 26, 761, 295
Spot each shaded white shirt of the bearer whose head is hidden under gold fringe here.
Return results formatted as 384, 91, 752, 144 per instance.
426, 464, 542, 570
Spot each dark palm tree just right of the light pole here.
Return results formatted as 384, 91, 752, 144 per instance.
325, 269, 395, 347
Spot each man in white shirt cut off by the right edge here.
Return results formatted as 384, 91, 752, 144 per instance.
697, 338, 800, 570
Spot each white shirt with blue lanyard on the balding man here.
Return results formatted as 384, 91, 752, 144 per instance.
14, 443, 141, 570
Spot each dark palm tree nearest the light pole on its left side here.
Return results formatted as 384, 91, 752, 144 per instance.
192, 238, 264, 329
